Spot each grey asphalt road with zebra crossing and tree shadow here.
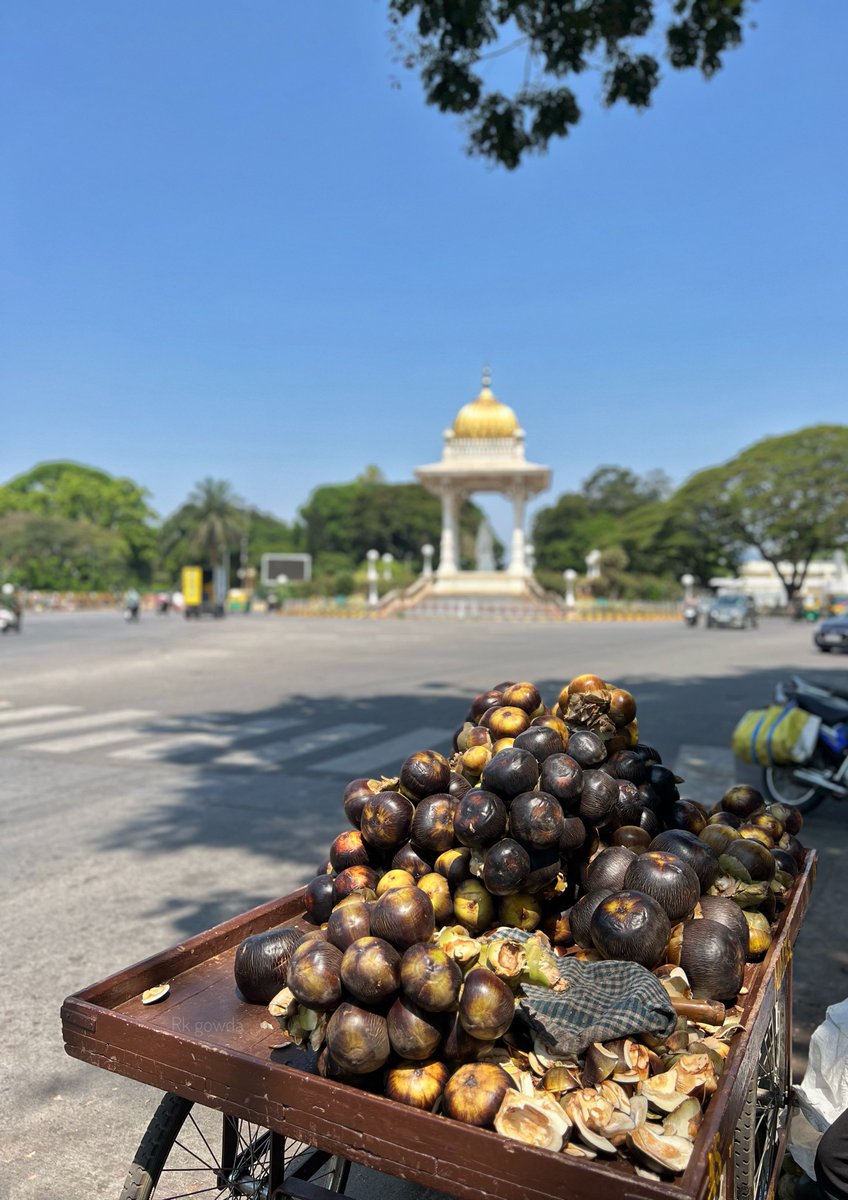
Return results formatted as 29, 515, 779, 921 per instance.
0, 613, 848, 1200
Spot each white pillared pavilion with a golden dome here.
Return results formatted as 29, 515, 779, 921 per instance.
415, 370, 551, 596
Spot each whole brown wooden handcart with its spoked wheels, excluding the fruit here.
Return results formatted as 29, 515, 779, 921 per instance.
62, 851, 816, 1200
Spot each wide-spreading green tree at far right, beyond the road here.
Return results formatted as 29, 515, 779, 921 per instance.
672, 425, 848, 600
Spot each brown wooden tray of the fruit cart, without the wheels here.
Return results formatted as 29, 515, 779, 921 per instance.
61, 851, 816, 1200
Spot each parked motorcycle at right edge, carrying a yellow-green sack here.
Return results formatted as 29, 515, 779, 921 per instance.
763, 676, 848, 812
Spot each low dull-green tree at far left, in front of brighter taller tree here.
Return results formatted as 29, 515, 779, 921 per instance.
0, 512, 128, 592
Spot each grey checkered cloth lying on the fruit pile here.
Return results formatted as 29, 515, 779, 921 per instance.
518, 958, 676, 1056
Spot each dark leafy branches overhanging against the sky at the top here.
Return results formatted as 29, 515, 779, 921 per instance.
389, 0, 752, 169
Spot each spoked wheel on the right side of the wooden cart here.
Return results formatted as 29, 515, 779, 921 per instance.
730, 972, 789, 1200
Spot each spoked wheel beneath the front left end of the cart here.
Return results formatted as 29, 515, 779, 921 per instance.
120, 1096, 350, 1200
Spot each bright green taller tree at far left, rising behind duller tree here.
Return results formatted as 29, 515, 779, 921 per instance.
0, 462, 156, 581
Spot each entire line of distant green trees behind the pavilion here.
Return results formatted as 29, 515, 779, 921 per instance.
0, 425, 848, 599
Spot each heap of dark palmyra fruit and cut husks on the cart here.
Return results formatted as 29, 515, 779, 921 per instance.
235, 674, 804, 1176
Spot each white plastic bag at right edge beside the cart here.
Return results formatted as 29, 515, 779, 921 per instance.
788, 1000, 848, 1178
